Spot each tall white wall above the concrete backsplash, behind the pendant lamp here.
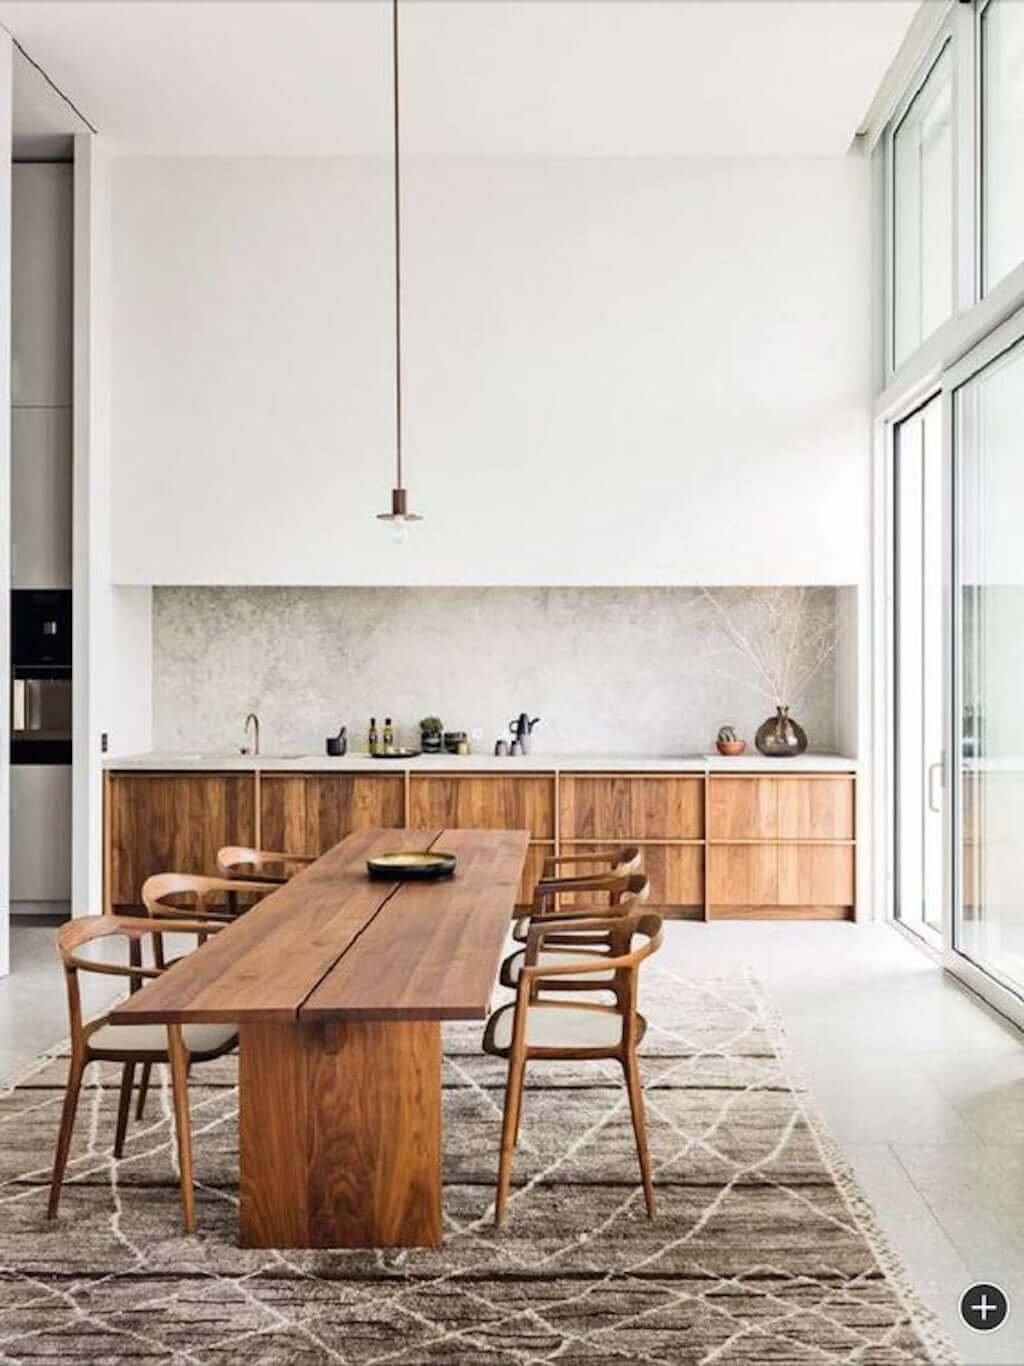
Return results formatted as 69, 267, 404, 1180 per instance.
112, 157, 871, 585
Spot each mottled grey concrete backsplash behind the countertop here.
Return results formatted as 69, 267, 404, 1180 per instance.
153, 587, 840, 755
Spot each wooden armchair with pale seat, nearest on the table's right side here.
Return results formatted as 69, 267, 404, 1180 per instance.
483, 911, 662, 1224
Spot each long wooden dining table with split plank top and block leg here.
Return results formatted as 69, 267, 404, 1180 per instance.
111, 829, 530, 1247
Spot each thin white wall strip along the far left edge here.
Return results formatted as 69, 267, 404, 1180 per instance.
0, 30, 14, 977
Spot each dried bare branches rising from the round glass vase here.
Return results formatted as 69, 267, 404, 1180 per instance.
702, 587, 840, 706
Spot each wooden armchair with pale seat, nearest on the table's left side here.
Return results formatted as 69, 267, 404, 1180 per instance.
46, 915, 236, 1233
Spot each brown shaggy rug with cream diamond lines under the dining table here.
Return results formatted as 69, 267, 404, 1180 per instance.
0, 964, 953, 1366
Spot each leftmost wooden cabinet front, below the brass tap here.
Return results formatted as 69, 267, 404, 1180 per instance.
106, 773, 255, 908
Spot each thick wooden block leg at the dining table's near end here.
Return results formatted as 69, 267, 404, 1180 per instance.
239, 1020, 441, 1247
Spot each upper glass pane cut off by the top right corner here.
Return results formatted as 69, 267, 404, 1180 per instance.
982, 0, 1024, 290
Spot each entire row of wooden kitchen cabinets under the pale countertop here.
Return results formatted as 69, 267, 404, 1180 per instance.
106, 769, 856, 919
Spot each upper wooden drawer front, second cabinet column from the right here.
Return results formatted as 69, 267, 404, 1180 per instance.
560, 773, 705, 840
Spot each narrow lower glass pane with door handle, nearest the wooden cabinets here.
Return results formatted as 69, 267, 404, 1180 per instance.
896, 398, 945, 940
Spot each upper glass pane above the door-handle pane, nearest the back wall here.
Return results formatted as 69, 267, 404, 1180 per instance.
893, 44, 953, 365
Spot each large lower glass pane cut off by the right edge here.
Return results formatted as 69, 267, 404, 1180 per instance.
953, 336, 1024, 989
